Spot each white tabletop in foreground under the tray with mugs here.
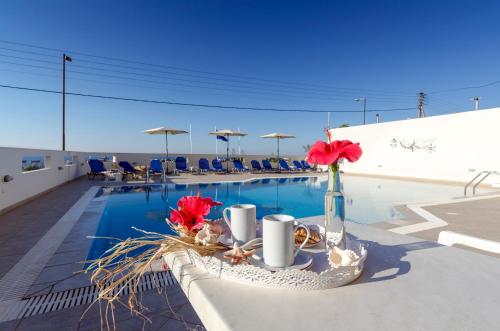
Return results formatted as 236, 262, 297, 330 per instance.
164, 218, 500, 331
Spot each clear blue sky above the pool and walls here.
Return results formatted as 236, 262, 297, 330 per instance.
0, 1, 500, 154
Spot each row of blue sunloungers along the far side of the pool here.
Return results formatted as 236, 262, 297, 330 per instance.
87, 156, 312, 179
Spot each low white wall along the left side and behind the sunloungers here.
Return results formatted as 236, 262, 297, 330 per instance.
0, 147, 304, 214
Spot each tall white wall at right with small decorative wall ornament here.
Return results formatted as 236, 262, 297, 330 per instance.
332, 108, 500, 184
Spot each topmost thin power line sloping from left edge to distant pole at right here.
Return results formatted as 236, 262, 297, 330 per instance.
0, 40, 411, 96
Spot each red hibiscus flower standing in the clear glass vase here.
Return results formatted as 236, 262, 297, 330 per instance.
307, 140, 363, 165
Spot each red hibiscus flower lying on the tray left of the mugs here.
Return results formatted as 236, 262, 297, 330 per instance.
170, 195, 222, 231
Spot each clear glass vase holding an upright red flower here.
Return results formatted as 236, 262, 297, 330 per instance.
325, 167, 346, 250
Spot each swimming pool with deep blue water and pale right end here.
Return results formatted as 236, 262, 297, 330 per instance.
88, 176, 484, 259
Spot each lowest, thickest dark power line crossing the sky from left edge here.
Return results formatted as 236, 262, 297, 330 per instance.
0, 84, 415, 113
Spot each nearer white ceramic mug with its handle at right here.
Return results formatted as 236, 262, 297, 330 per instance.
262, 215, 310, 268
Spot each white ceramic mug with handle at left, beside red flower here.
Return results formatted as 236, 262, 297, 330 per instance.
222, 204, 257, 245
